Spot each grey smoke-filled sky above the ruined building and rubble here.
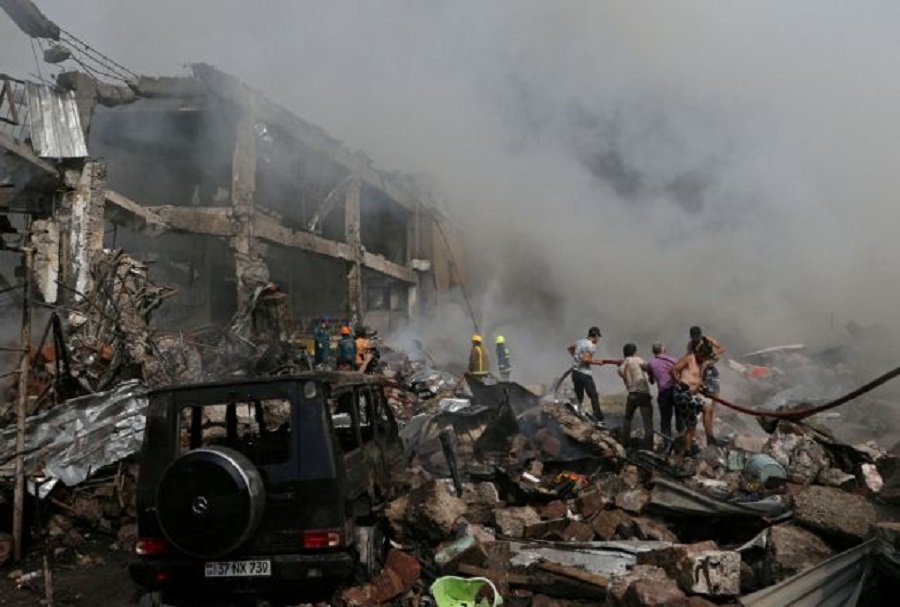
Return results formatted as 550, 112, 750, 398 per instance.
0, 0, 900, 388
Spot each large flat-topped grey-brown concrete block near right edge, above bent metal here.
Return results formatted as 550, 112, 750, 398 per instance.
794, 485, 878, 542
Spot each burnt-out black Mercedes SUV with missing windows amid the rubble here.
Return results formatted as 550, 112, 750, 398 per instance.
129, 372, 403, 605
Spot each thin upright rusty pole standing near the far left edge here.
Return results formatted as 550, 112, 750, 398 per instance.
13, 247, 34, 562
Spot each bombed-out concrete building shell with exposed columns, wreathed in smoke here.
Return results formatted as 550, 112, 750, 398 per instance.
0, 17, 464, 346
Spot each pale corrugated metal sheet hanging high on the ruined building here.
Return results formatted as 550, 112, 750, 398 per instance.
25, 82, 88, 158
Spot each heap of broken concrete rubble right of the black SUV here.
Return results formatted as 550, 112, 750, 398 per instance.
338, 378, 898, 606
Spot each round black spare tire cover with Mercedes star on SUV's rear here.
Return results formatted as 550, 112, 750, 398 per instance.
156, 447, 266, 558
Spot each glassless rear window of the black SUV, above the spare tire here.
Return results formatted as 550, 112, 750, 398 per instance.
179, 398, 291, 466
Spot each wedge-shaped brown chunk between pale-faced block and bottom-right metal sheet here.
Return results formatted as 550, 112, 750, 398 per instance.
762, 523, 834, 586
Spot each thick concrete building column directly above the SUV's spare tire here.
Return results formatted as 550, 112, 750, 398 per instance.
231, 102, 269, 310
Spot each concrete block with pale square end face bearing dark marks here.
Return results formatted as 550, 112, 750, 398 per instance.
637, 541, 741, 597
